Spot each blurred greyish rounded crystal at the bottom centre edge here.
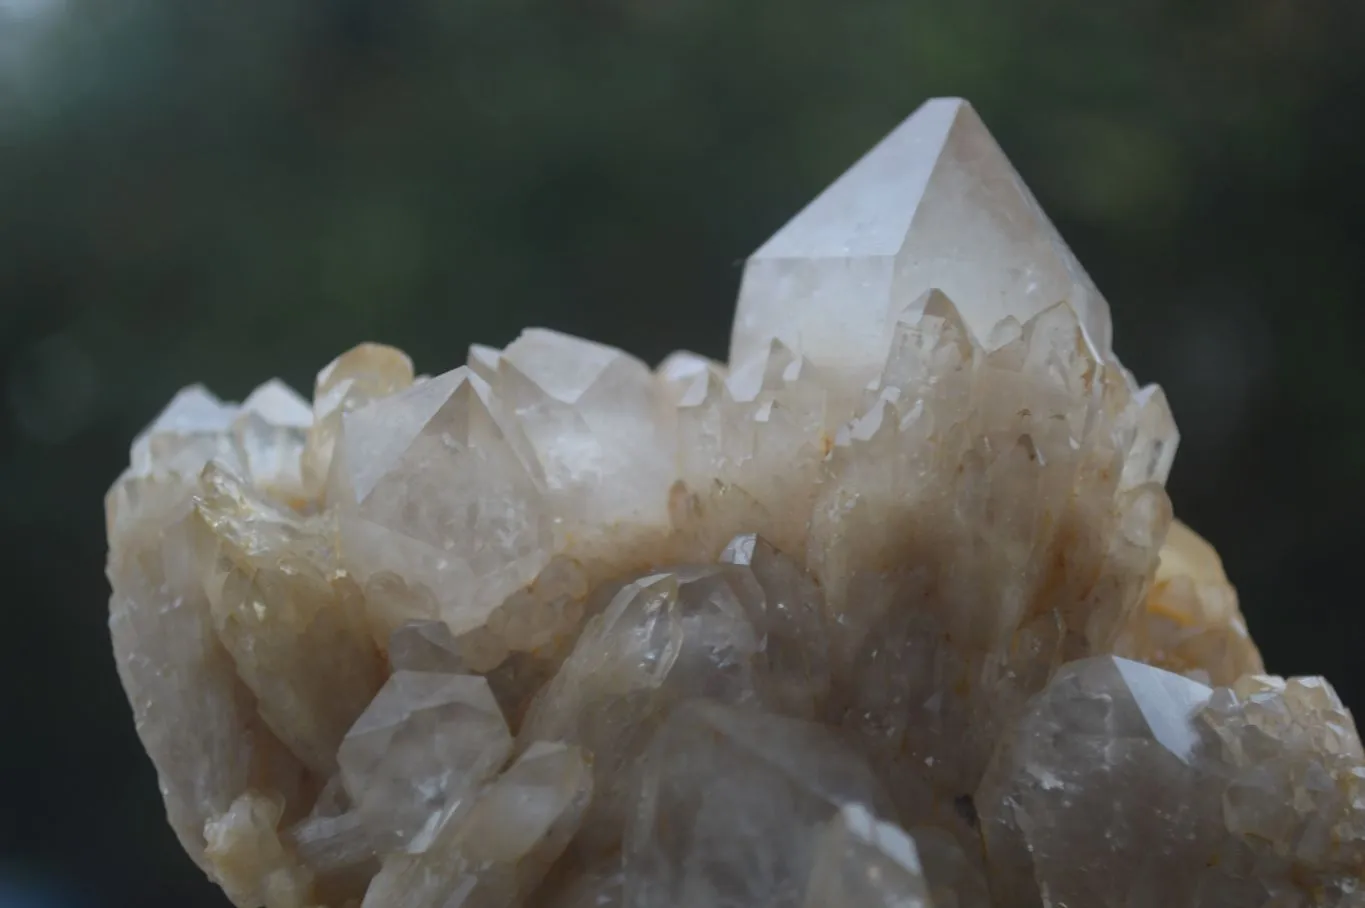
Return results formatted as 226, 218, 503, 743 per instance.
625, 702, 895, 908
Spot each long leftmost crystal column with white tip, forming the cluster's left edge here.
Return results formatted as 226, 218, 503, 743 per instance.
105, 386, 312, 868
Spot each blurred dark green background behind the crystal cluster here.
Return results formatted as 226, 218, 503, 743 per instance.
0, 0, 1365, 908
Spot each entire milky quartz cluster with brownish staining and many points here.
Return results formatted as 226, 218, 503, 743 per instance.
108, 100, 1365, 908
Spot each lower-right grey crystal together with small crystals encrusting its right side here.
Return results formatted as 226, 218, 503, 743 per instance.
976, 657, 1365, 908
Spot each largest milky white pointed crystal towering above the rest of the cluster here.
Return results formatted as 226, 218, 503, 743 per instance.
730, 98, 1111, 386
